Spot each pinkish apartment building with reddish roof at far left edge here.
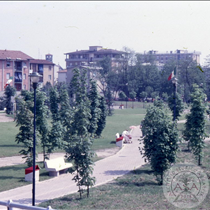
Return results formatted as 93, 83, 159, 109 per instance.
0, 50, 54, 92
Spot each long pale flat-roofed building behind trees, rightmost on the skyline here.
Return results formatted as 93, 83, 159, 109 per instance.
141, 50, 201, 65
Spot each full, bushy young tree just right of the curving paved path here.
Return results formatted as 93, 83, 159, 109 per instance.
139, 103, 178, 184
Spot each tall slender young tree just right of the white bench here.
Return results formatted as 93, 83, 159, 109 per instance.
65, 69, 95, 198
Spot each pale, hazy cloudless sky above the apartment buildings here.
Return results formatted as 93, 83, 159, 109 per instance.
0, 1, 210, 68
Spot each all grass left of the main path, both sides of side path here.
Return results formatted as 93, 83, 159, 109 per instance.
0, 109, 144, 194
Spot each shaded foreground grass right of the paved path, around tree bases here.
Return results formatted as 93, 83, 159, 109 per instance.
40, 142, 210, 210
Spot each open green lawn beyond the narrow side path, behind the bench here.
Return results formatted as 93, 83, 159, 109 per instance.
0, 109, 146, 157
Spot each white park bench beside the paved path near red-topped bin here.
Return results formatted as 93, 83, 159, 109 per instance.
44, 157, 73, 176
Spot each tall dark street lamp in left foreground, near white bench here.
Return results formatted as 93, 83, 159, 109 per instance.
29, 72, 41, 206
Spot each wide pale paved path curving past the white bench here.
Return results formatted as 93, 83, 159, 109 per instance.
0, 126, 144, 209
